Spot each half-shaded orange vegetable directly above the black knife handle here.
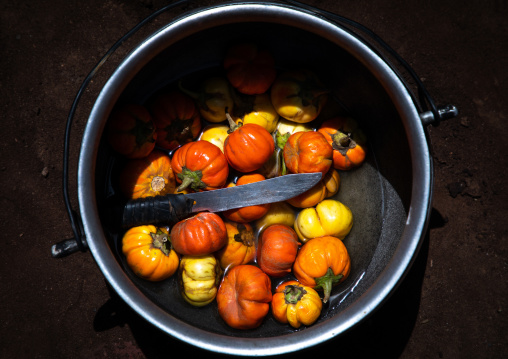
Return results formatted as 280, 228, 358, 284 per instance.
119, 150, 176, 199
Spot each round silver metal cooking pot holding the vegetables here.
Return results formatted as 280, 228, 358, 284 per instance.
53, 2, 456, 356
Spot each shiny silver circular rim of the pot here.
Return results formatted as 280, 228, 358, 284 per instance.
78, 3, 432, 356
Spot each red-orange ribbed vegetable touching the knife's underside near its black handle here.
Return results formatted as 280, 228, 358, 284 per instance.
171, 212, 228, 256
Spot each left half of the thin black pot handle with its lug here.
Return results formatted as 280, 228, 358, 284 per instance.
51, 0, 189, 258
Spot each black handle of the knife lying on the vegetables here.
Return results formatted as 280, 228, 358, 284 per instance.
122, 194, 193, 228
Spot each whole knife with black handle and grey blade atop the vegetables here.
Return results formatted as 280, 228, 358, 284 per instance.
121, 172, 322, 228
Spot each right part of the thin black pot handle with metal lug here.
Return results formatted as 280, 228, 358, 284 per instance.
284, 0, 458, 126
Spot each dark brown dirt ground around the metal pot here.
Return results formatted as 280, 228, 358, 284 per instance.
0, 0, 508, 359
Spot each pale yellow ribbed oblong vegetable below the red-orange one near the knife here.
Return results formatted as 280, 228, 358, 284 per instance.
178, 254, 222, 307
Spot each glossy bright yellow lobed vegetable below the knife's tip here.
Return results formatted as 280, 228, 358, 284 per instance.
294, 199, 353, 243
